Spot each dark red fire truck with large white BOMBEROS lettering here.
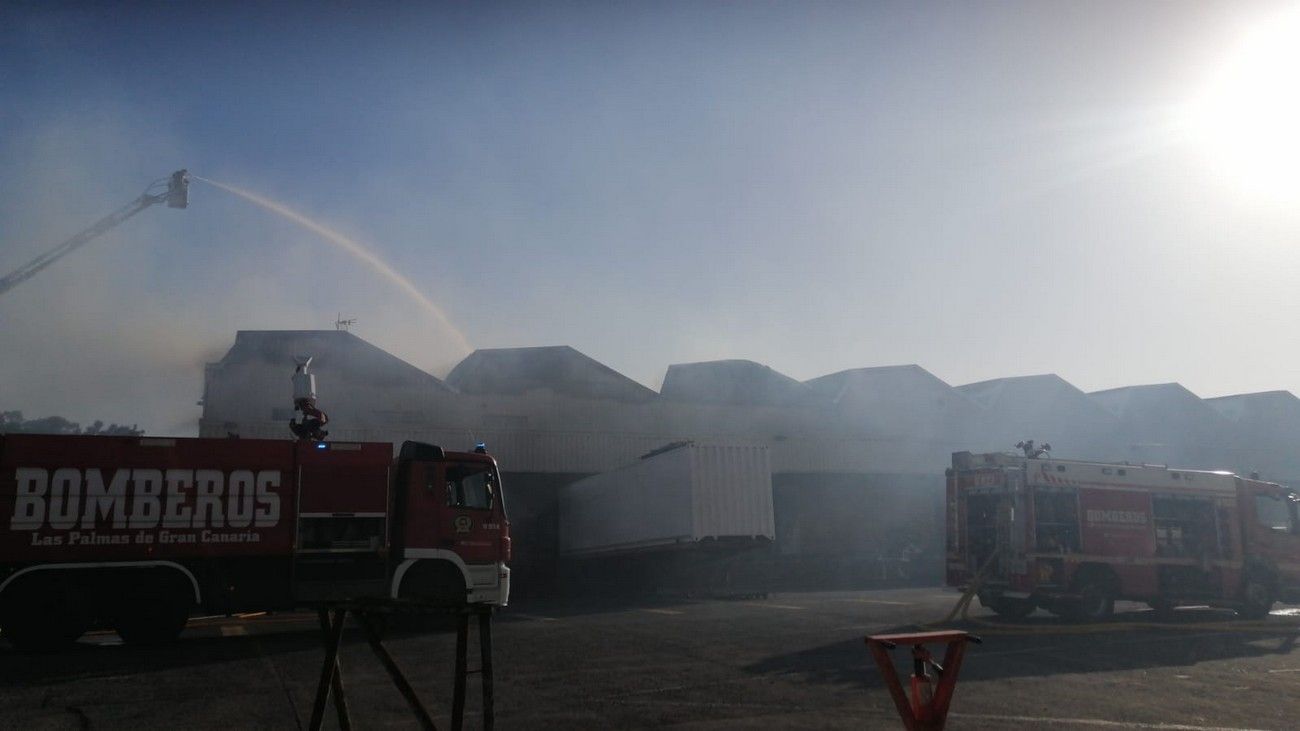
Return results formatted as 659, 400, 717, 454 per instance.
0, 434, 511, 648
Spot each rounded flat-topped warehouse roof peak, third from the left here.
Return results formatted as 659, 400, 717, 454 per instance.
659, 360, 811, 406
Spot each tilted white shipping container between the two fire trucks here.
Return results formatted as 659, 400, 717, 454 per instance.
559, 442, 776, 557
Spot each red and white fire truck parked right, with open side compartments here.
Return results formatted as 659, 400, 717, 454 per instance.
948, 451, 1300, 619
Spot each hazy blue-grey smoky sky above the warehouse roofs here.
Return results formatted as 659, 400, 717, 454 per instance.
0, 0, 1300, 433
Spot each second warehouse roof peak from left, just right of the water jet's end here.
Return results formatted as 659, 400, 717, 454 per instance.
447, 345, 655, 401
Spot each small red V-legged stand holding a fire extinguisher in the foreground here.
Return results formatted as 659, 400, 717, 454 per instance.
867, 631, 980, 731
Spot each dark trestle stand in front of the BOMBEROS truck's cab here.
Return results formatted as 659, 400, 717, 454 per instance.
308, 602, 494, 731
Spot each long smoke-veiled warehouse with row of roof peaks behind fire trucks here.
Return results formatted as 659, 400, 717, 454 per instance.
200, 330, 1300, 594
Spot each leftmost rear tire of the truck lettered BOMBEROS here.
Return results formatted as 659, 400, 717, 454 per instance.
0, 575, 91, 652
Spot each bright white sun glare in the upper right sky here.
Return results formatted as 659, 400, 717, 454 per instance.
1188, 9, 1300, 200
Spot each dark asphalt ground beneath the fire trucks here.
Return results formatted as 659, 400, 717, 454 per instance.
0, 588, 1300, 731
